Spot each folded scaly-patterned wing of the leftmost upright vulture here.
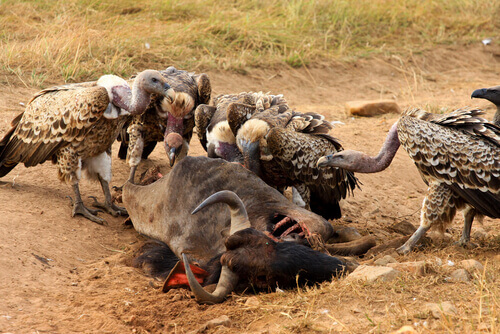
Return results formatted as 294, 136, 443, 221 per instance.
0, 82, 110, 171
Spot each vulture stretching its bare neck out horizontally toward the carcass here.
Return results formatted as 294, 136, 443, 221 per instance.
318, 108, 500, 254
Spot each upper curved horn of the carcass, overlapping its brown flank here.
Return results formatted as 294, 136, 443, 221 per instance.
191, 190, 250, 235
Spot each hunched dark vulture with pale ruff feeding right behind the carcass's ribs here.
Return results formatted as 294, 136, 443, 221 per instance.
227, 105, 359, 219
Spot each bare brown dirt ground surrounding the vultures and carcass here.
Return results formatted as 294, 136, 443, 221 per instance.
0, 45, 500, 333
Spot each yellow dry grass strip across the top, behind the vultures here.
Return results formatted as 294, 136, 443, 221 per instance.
0, 0, 500, 87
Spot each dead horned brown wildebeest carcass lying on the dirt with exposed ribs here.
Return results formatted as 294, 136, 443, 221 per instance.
123, 157, 373, 303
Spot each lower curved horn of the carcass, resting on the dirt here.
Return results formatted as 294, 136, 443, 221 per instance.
182, 253, 238, 304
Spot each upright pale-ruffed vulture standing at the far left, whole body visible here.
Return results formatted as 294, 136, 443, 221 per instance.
0, 70, 175, 224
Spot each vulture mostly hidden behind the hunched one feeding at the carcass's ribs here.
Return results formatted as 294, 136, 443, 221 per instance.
195, 92, 286, 162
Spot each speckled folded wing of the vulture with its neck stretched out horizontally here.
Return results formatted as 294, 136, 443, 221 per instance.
398, 109, 500, 218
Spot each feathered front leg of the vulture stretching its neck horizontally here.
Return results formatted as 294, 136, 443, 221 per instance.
396, 182, 458, 254
